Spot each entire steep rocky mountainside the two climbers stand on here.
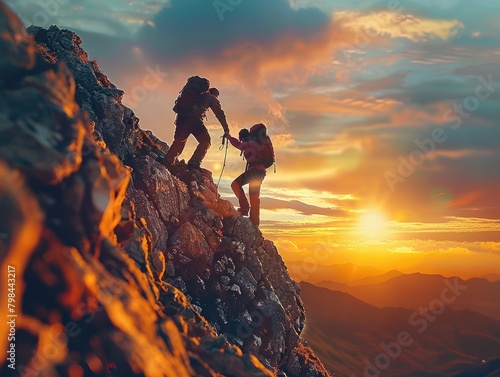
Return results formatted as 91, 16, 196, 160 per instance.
0, 2, 329, 377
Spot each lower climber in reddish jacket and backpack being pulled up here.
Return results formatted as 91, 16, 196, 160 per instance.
228, 123, 274, 225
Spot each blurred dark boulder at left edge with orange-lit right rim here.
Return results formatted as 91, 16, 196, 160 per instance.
0, 49, 85, 184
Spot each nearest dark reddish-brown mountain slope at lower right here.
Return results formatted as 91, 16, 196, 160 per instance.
300, 282, 500, 377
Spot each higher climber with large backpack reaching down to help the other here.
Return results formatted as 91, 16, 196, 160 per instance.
164, 76, 229, 169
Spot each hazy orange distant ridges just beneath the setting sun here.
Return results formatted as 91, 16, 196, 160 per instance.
317, 273, 500, 320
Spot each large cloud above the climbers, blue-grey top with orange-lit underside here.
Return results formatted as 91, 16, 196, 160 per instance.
137, 0, 351, 129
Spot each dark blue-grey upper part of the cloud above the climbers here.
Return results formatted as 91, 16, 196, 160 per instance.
139, 0, 330, 64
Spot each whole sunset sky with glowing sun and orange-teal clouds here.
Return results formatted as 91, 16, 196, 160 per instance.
6, 0, 500, 280
